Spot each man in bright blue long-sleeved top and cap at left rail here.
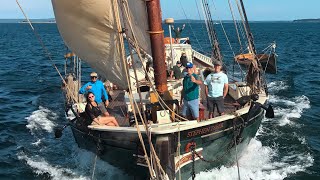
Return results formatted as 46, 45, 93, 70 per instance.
79, 72, 109, 116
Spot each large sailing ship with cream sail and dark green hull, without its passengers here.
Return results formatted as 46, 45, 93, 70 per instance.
52, 0, 273, 179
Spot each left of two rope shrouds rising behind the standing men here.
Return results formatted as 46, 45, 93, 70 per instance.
202, 0, 222, 61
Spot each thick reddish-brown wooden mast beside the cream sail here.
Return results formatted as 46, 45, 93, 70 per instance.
146, 0, 168, 94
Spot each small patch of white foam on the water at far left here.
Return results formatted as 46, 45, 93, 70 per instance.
25, 106, 57, 134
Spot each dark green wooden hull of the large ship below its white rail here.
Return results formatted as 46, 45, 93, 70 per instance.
71, 102, 264, 179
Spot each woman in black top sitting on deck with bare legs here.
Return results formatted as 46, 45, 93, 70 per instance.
85, 92, 119, 126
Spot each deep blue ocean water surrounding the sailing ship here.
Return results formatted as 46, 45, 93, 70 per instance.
0, 22, 320, 180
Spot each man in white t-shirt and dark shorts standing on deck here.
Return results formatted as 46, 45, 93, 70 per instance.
204, 61, 228, 118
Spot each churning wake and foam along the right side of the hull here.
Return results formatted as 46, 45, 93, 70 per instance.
196, 81, 314, 180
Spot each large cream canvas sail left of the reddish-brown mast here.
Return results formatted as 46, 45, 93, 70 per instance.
52, 0, 151, 88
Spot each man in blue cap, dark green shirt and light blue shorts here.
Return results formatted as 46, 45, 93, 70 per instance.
181, 62, 202, 121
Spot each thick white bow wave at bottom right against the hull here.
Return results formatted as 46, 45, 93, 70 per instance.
196, 139, 314, 180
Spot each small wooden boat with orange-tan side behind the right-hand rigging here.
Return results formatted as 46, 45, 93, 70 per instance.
235, 53, 277, 74
